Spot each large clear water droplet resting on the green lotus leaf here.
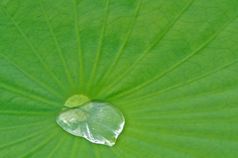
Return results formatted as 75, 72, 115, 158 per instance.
56, 101, 125, 146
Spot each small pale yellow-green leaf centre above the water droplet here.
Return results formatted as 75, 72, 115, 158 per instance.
64, 94, 89, 108
